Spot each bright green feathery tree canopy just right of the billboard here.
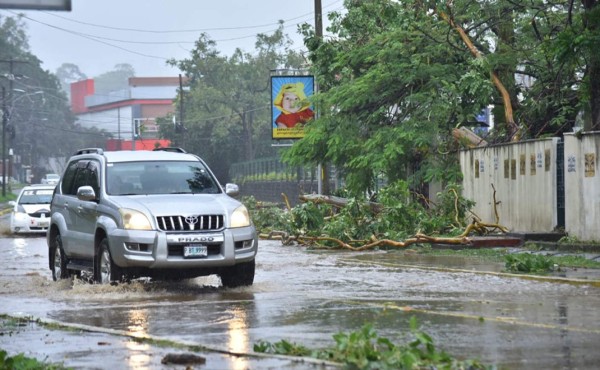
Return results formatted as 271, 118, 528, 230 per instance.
286, 0, 493, 195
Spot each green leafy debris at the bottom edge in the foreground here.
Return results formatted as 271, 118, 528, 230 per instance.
254, 317, 493, 370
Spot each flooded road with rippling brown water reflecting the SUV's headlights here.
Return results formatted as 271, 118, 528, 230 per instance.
0, 224, 600, 369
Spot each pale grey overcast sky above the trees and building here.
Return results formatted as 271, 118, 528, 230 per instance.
0, 0, 343, 78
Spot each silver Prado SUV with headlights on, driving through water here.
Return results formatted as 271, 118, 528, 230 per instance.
47, 148, 258, 287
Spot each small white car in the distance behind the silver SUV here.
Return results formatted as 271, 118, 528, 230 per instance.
9, 184, 55, 234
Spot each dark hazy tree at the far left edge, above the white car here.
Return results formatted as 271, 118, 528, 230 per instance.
0, 13, 105, 177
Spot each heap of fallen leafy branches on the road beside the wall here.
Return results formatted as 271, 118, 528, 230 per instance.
244, 180, 482, 249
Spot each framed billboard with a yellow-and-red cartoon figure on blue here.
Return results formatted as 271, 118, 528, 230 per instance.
271, 76, 315, 139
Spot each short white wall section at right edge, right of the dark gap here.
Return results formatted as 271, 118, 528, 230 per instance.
564, 131, 600, 241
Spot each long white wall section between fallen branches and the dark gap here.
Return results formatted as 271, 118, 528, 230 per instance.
460, 138, 559, 232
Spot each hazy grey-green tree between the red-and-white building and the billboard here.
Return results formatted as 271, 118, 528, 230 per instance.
161, 23, 302, 181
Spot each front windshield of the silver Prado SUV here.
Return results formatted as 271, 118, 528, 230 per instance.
106, 161, 221, 195
